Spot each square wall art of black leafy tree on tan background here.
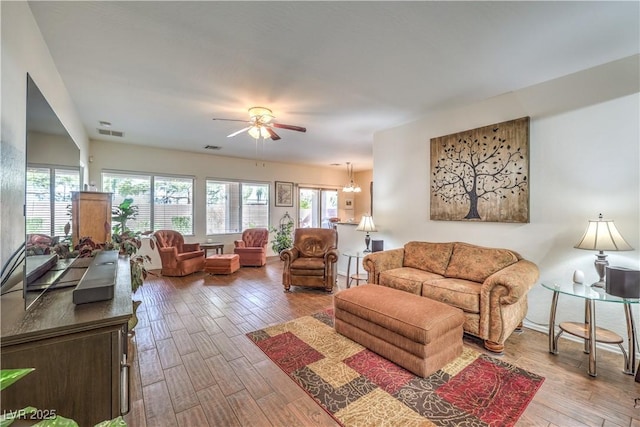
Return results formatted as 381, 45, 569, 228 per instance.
431, 117, 529, 223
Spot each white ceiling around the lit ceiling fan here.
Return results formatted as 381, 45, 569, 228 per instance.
29, 1, 640, 170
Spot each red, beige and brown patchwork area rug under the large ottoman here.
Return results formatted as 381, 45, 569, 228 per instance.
247, 310, 544, 427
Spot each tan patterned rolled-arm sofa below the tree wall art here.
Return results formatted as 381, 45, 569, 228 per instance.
363, 242, 539, 353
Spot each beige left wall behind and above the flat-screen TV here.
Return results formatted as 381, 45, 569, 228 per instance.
0, 1, 89, 263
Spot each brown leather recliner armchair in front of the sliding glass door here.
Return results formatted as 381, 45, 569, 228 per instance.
280, 228, 338, 292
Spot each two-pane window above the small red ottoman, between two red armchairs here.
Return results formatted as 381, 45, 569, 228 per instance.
206, 179, 269, 235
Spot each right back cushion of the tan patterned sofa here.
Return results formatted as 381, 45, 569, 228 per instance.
444, 243, 519, 283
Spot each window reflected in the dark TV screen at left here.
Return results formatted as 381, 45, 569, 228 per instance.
25, 165, 80, 236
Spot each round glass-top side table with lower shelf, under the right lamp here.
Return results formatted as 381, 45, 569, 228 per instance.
542, 281, 640, 377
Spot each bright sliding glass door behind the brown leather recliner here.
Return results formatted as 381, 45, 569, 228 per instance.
298, 186, 338, 228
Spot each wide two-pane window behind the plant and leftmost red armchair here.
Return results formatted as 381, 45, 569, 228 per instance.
102, 172, 194, 235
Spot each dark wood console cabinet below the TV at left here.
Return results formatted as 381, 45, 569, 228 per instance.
0, 257, 132, 426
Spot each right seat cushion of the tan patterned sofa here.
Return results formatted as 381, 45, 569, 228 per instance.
422, 278, 482, 313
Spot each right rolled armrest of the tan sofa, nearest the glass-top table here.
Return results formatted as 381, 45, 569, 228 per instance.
481, 259, 540, 305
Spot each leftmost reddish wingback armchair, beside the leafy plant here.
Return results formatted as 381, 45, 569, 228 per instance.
153, 230, 204, 276
